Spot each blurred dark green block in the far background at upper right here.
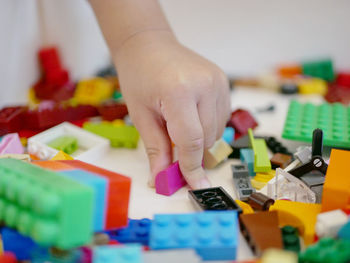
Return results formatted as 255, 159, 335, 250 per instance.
302, 59, 335, 82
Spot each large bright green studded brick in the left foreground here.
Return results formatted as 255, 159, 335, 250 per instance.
0, 159, 94, 249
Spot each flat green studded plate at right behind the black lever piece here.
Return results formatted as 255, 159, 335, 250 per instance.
282, 101, 350, 148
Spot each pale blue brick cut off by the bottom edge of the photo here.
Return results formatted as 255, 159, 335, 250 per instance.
92, 244, 143, 263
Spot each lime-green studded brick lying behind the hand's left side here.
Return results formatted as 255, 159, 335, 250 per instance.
83, 122, 140, 148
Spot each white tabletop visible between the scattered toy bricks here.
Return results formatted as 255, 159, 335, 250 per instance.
85, 87, 322, 259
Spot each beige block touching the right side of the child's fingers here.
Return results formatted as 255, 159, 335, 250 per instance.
203, 139, 232, 169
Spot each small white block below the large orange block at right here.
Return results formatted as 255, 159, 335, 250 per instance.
316, 209, 348, 238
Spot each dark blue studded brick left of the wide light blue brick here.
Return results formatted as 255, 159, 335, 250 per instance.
107, 218, 152, 246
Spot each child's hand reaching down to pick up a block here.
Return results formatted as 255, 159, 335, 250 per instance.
113, 30, 230, 188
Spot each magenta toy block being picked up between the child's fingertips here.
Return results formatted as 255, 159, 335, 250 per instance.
155, 161, 187, 196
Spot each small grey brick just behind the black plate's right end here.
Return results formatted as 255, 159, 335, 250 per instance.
231, 164, 255, 201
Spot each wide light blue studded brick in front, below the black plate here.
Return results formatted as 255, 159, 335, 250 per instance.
150, 211, 238, 260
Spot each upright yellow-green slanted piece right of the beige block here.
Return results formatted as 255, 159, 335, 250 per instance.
248, 129, 271, 173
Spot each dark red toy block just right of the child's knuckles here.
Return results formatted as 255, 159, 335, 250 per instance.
227, 109, 258, 135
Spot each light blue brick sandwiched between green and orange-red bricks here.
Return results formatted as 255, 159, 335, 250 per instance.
61, 170, 108, 232
